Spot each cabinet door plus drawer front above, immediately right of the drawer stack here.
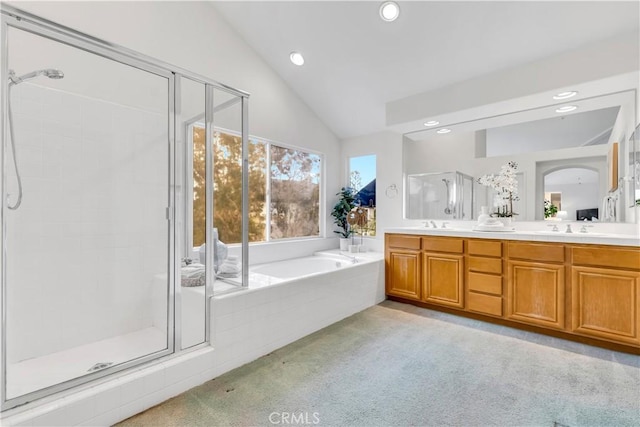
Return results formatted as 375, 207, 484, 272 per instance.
507, 242, 565, 329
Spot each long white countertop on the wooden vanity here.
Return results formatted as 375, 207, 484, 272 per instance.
385, 225, 640, 246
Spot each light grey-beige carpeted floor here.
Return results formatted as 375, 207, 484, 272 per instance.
119, 301, 640, 427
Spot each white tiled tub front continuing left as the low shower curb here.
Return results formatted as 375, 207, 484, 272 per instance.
0, 251, 385, 426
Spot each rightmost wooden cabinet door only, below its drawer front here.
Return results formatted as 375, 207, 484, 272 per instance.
571, 267, 640, 344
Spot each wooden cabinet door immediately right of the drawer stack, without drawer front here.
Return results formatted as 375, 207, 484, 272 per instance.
507, 260, 565, 329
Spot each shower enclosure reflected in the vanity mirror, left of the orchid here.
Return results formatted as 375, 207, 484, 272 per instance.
405, 172, 475, 220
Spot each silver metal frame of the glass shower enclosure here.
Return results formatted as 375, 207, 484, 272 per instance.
0, 4, 249, 411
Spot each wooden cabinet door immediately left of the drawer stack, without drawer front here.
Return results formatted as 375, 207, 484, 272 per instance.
422, 252, 464, 308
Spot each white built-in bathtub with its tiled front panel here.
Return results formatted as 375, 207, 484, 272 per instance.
211, 250, 385, 370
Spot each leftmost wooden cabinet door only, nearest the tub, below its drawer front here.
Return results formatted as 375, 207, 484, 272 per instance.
387, 249, 420, 300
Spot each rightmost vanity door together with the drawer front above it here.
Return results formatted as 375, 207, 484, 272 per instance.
571, 246, 640, 345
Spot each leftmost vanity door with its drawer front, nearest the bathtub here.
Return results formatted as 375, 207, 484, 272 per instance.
385, 234, 421, 300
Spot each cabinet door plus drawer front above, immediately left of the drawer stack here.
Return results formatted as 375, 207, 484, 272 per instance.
422, 237, 464, 308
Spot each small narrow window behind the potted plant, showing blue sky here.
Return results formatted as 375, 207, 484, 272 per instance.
349, 154, 376, 237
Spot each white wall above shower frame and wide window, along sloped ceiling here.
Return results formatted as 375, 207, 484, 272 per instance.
8, 1, 341, 254
